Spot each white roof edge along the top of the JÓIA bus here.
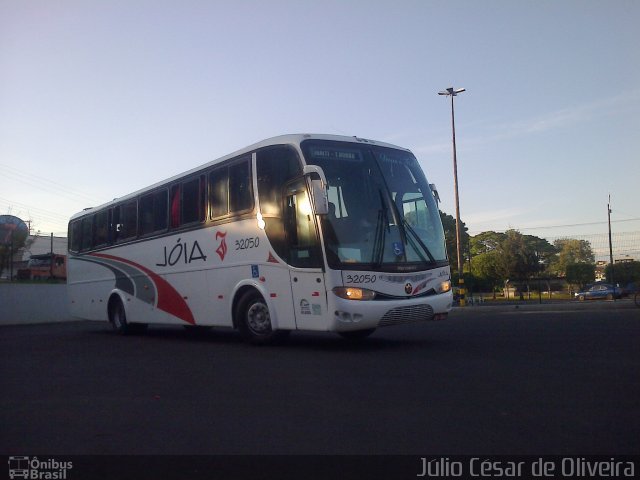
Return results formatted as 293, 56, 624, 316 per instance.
70, 133, 409, 220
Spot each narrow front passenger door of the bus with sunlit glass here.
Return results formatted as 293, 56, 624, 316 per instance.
284, 179, 327, 330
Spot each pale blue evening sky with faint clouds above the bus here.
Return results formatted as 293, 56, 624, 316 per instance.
0, 0, 640, 258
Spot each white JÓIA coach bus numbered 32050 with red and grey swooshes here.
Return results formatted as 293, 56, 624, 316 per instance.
68, 135, 452, 343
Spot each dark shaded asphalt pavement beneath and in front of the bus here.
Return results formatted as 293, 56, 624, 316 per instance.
0, 302, 640, 455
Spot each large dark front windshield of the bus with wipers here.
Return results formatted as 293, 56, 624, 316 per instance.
302, 140, 448, 271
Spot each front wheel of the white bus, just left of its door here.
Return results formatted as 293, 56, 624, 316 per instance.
235, 290, 289, 345
